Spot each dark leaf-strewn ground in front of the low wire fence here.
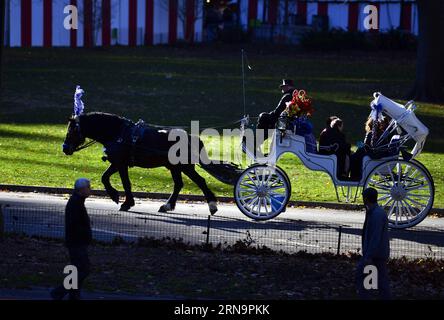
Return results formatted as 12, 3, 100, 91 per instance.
0, 237, 444, 299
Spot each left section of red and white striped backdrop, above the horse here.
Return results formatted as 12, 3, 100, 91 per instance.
5, 0, 203, 47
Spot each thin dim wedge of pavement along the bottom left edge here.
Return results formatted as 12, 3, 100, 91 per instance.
0, 287, 185, 300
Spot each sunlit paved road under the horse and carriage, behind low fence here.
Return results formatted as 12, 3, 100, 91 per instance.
0, 192, 444, 258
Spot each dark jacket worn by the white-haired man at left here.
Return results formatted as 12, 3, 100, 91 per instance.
65, 193, 92, 247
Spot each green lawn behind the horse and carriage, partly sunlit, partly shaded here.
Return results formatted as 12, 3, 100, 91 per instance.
0, 46, 444, 208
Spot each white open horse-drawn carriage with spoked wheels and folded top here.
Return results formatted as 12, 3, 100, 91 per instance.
234, 93, 435, 228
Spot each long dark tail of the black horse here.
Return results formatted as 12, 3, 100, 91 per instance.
199, 139, 242, 185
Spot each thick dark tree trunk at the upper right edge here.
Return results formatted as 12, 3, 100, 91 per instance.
409, 0, 444, 102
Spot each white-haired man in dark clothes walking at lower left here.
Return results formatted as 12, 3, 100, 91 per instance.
51, 178, 92, 300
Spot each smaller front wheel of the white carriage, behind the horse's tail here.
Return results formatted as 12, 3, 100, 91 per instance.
234, 165, 291, 220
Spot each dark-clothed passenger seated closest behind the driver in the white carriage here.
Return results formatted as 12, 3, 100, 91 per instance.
319, 116, 351, 180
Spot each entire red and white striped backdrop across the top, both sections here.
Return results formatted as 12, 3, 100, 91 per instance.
5, 0, 418, 47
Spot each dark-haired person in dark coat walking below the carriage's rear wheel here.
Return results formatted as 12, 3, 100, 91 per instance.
356, 188, 390, 300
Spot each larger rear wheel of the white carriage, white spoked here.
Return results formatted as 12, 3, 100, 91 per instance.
365, 160, 435, 229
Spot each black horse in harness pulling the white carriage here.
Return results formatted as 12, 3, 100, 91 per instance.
63, 112, 227, 214
